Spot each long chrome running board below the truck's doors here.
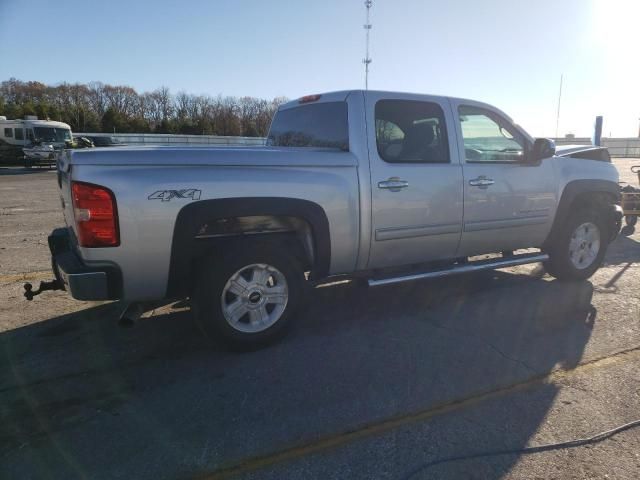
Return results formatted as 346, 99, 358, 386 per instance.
369, 253, 549, 287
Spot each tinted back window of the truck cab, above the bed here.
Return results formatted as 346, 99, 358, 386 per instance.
267, 101, 349, 151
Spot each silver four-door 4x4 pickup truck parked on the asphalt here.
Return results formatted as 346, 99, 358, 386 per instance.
38, 90, 621, 348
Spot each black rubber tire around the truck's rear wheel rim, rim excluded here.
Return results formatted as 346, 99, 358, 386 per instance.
192, 241, 306, 351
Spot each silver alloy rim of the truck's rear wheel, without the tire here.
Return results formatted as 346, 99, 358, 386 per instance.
221, 263, 289, 333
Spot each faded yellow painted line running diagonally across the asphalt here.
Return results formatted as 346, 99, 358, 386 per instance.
194, 346, 640, 480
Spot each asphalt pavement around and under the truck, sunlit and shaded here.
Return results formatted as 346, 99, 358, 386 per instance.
0, 160, 640, 479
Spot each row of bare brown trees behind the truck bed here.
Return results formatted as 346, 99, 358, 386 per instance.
0, 78, 287, 137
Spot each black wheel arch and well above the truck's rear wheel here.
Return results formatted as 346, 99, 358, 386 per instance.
165, 197, 331, 298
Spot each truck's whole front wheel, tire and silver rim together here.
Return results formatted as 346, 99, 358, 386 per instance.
545, 209, 609, 280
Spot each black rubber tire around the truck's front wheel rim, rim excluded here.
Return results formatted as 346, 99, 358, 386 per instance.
544, 208, 610, 281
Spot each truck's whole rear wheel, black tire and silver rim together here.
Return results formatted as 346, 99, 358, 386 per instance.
193, 242, 305, 350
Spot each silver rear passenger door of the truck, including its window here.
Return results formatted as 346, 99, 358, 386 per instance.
366, 92, 462, 268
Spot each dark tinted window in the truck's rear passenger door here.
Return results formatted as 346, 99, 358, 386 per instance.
375, 100, 449, 163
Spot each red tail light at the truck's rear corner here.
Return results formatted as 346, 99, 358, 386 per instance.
71, 182, 120, 247
